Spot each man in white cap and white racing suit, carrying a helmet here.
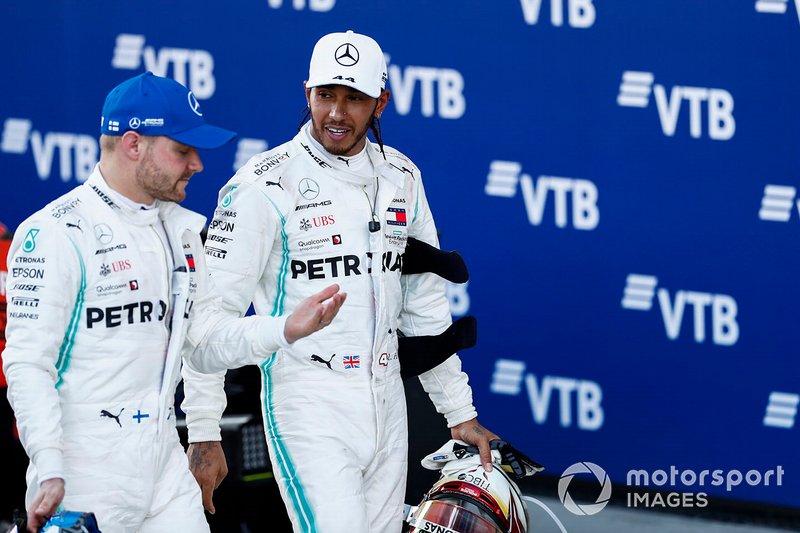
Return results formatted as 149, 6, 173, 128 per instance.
189, 31, 497, 533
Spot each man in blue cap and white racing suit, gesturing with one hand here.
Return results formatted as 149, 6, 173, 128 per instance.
3, 72, 344, 533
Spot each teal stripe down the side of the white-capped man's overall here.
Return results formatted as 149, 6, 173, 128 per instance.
259, 200, 317, 533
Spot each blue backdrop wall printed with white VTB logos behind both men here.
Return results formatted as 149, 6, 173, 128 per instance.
0, 0, 800, 507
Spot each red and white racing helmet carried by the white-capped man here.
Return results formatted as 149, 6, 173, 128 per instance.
406, 440, 528, 533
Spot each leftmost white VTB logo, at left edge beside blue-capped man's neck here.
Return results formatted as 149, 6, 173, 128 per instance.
0, 118, 99, 182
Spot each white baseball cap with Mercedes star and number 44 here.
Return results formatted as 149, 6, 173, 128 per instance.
306, 30, 386, 98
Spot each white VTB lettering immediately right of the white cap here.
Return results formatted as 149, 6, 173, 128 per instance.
387, 59, 467, 119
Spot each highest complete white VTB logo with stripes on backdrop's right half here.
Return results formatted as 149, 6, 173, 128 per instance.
617, 70, 736, 141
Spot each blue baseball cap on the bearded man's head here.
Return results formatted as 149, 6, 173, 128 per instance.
100, 72, 236, 148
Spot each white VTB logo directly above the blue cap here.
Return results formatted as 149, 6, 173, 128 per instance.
111, 33, 217, 100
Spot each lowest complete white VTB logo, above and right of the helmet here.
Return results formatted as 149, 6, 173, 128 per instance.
489, 359, 605, 431
